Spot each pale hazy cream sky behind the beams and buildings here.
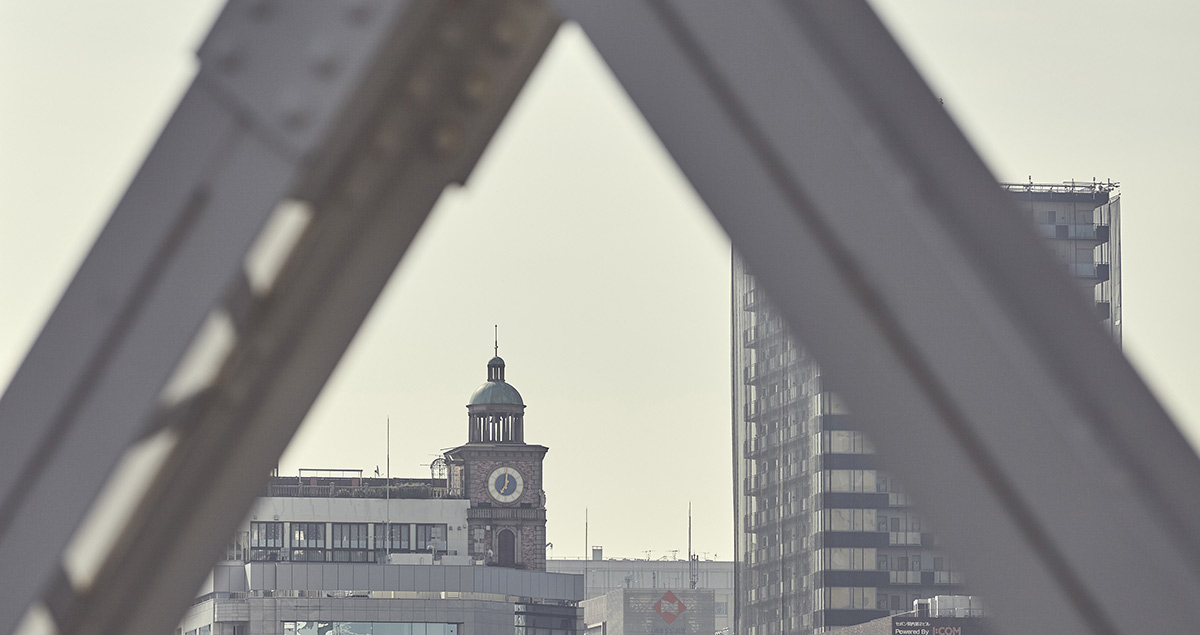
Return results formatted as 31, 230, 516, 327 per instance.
0, 0, 1200, 558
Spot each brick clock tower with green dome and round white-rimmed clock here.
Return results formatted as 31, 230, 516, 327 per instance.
445, 355, 548, 571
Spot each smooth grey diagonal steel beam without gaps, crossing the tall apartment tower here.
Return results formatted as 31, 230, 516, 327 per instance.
559, 1, 1200, 634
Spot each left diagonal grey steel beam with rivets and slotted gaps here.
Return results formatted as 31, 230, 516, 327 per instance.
0, 1, 558, 633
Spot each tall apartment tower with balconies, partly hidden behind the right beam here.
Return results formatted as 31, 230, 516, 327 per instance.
732, 182, 1121, 635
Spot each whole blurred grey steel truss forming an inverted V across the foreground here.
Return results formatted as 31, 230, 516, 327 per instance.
0, 0, 1200, 635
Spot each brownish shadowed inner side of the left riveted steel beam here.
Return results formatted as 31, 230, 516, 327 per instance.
64, 2, 558, 633
